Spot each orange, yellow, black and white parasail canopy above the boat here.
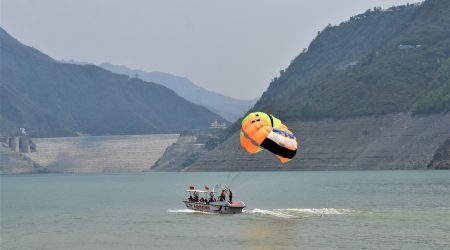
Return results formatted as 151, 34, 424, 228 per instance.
240, 112, 297, 163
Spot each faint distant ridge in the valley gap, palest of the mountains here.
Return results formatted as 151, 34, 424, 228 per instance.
99, 63, 256, 122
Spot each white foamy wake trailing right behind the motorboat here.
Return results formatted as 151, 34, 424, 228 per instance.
243, 208, 356, 219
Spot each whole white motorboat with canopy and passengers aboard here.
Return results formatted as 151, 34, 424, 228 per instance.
183, 185, 245, 214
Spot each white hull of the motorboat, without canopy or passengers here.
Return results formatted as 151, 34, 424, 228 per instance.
183, 200, 245, 214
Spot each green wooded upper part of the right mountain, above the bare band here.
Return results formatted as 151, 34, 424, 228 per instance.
254, 0, 450, 119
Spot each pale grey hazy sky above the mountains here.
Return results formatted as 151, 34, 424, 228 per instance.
0, 0, 418, 99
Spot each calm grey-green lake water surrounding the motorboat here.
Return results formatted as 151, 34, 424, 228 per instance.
0, 171, 450, 250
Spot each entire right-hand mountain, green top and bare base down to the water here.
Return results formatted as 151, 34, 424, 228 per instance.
179, 0, 450, 171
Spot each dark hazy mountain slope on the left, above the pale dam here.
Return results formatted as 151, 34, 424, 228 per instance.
0, 28, 223, 137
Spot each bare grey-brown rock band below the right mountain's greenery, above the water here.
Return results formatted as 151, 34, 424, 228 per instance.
184, 113, 450, 171
